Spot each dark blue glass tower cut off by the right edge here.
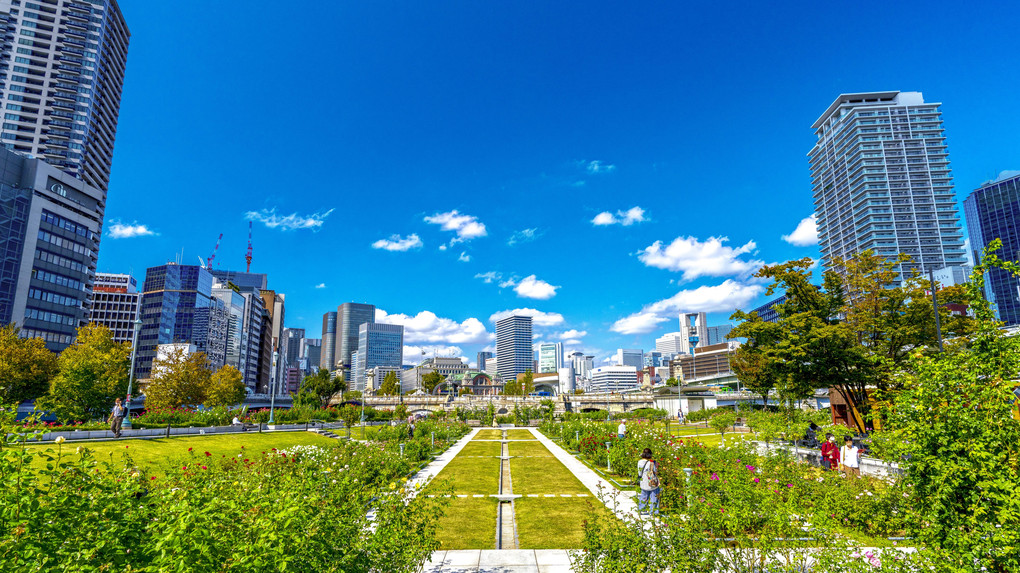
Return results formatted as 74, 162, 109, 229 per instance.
962, 171, 1020, 325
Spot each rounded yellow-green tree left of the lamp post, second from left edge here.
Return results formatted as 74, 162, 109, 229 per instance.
40, 323, 131, 421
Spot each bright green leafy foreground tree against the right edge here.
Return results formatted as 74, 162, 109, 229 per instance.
887, 240, 1020, 571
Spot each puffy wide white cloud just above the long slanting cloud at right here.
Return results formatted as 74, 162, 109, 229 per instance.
638, 237, 765, 280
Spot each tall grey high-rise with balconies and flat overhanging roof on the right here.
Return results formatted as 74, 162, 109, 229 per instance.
808, 92, 966, 280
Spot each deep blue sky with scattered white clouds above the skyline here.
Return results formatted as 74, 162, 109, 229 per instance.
99, 0, 1020, 362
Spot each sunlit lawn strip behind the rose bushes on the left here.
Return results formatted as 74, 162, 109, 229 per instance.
18, 431, 337, 474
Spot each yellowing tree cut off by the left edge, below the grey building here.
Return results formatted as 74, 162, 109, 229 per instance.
0, 324, 57, 404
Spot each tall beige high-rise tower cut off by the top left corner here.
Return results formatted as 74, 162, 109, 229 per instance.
0, 0, 131, 191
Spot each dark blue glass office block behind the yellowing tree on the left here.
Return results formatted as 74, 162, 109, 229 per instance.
135, 263, 228, 379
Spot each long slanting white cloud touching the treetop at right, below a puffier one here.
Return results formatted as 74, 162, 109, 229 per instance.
610, 279, 765, 334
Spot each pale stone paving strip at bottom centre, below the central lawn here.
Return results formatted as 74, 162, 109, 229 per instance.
422, 550, 572, 573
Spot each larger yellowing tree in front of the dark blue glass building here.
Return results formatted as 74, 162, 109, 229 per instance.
145, 348, 212, 409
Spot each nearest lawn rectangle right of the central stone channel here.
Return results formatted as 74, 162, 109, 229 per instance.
514, 497, 608, 550
